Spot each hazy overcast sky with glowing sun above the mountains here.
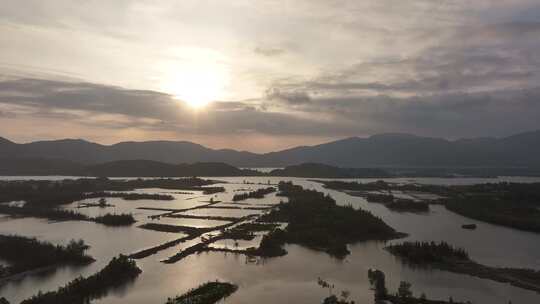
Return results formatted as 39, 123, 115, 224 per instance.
0, 0, 540, 152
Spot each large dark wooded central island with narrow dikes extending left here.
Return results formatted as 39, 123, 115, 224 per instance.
154, 182, 405, 263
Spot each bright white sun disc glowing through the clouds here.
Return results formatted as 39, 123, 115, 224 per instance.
160, 63, 226, 109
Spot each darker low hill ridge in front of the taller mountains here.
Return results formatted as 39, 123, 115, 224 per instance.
0, 158, 540, 178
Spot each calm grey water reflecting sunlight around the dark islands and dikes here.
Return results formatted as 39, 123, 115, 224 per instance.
0, 177, 540, 304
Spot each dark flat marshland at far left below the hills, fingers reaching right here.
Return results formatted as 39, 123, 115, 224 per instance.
0, 177, 225, 226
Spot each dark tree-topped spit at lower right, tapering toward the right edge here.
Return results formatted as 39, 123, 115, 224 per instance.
385, 242, 540, 293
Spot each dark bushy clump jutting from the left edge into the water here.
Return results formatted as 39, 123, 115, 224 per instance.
0, 235, 94, 278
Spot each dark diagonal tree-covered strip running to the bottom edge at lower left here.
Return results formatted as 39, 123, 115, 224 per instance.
21, 255, 141, 304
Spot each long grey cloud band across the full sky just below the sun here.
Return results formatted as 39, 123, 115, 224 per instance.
0, 79, 540, 137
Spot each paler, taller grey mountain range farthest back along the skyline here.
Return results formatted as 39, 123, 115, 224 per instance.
0, 130, 540, 168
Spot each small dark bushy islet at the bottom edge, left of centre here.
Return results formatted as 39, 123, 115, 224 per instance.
166, 281, 238, 304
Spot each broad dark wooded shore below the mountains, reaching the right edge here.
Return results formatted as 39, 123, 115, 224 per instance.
318, 181, 540, 232
